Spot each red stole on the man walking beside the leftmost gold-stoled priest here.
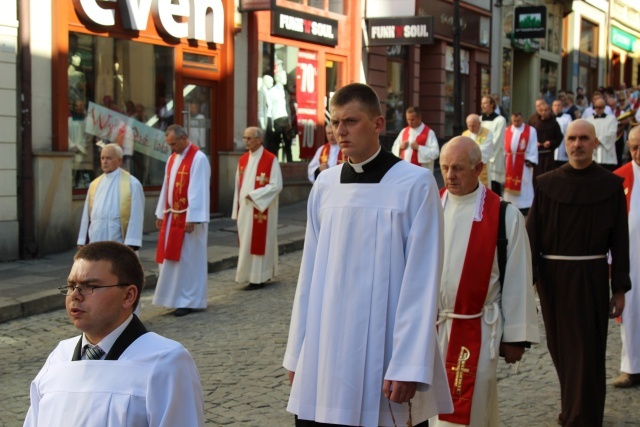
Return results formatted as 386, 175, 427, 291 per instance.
156, 144, 199, 264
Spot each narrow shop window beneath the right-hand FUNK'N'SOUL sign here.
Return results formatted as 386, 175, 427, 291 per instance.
385, 46, 408, 134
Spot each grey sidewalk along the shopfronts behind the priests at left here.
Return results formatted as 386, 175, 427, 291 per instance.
0, 201, 307, 323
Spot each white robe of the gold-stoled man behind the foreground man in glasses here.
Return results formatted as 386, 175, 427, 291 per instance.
78, 168, 144, 247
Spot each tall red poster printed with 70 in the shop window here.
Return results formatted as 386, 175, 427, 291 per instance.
296, 49, 324, 159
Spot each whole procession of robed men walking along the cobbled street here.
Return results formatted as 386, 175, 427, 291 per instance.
13, 83, 640, 427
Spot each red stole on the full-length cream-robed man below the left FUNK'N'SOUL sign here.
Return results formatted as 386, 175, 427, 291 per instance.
238, 149, 276, 255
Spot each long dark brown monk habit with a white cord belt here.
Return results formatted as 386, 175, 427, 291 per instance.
527, 162, 631, 426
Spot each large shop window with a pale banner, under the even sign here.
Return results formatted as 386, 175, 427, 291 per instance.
68, 33, 174, 189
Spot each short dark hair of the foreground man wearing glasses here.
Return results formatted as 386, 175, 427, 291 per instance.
73, 241, 144, 310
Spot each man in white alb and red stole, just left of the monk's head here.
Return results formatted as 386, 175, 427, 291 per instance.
504, 113, 538, 215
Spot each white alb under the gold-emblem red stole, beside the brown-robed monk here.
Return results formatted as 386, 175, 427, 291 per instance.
436, 184, 540, 427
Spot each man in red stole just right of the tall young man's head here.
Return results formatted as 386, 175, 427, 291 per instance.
391, 107, 440, 172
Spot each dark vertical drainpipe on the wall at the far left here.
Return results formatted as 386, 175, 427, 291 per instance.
18, 0, 38, 258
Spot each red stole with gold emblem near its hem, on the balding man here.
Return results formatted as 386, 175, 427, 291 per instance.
439, 188, 500, 425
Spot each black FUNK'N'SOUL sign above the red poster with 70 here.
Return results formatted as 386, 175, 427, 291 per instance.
271, 7, 338, 46
